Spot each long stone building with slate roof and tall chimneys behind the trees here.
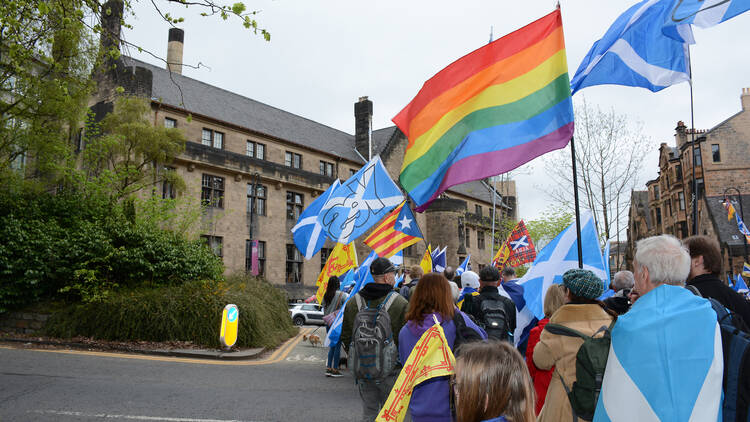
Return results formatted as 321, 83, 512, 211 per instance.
94, 29, 517, 297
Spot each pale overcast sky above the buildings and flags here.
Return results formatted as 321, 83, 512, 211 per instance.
124, 0, 750, 219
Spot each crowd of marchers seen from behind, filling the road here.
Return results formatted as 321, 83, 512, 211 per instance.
324, 235, 750, 422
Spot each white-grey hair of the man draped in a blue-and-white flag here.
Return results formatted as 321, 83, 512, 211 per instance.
635, 234, 690, 286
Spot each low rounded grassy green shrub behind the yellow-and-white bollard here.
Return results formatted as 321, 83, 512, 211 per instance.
45, 277, 296, 348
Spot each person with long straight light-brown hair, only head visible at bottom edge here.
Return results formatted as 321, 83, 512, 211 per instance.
452, 341, 535, 422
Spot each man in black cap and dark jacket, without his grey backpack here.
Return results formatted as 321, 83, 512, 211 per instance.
341, 258, 409, 421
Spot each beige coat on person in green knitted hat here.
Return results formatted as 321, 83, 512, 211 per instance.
534, 305, 612, 422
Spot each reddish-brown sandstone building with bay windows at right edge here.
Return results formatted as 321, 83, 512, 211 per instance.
626, 88, 750, 273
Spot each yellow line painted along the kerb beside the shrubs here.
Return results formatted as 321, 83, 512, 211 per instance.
0, 327, 313, 366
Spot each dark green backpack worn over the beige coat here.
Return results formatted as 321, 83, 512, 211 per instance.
544, 321, 615, 421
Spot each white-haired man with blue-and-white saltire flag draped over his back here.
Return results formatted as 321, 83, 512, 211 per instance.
594, 235, 723, 422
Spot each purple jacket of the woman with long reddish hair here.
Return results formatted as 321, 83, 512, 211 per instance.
398, 309, 487, 422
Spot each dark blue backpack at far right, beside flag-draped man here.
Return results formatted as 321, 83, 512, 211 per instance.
686, 285, 750, 422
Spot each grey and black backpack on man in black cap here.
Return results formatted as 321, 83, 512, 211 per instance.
349, 292, 398, 381
